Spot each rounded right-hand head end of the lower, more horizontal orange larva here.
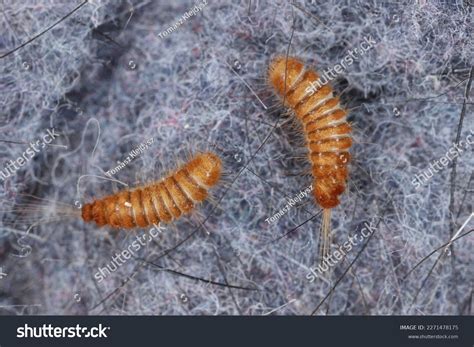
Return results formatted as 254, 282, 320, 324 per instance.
186, 152, 222, 187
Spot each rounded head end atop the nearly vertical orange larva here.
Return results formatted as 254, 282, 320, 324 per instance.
268, 56, 304, 96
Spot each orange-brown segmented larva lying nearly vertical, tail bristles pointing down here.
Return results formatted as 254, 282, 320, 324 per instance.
269, 57, 352, 209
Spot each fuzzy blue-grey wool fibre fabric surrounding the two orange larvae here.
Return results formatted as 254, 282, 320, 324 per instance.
0, 0, 474, 315
